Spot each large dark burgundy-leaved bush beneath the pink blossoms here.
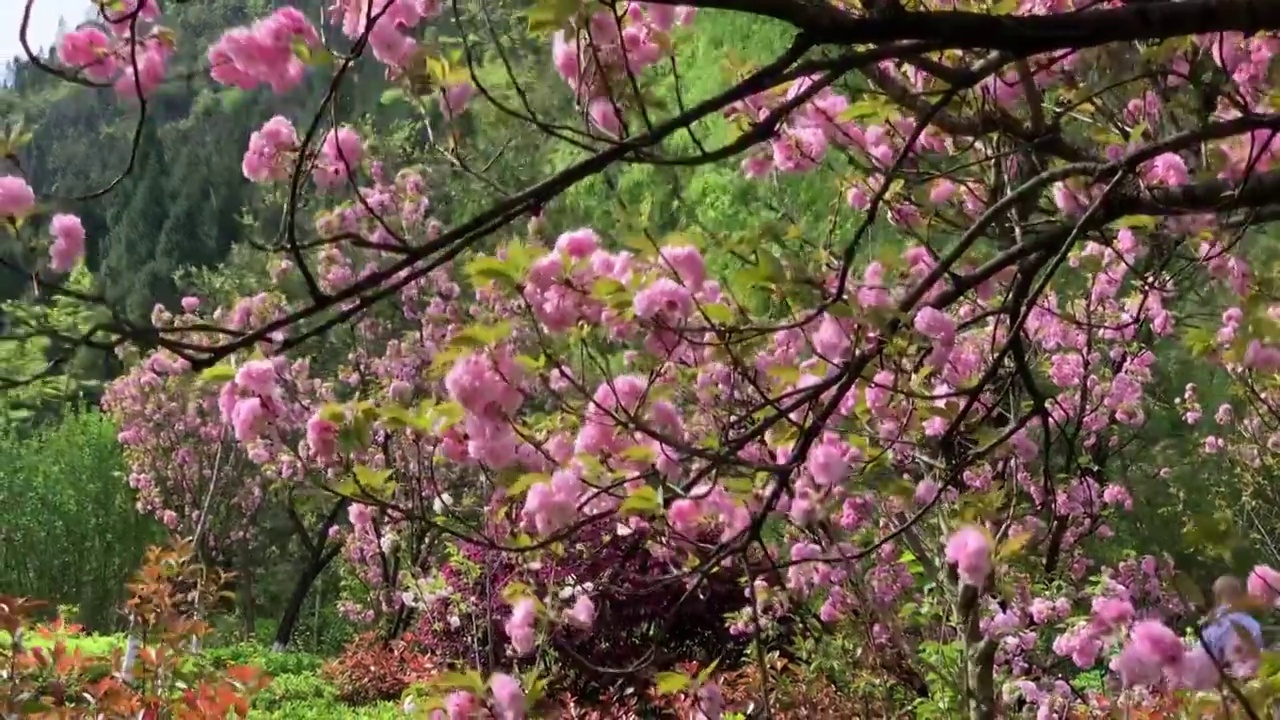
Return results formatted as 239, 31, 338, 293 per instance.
415, 517, 748, 692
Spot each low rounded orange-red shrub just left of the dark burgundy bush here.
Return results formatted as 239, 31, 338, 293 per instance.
324, 633, 439, 705
